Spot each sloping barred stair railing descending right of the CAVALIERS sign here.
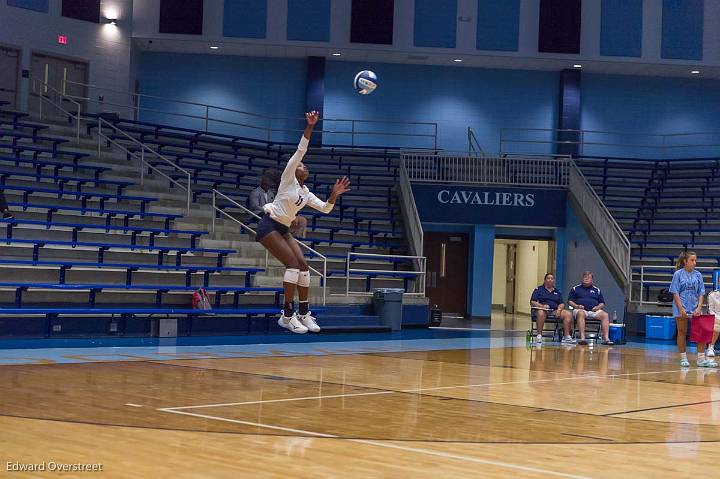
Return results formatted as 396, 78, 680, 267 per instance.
569, 161, 630, 288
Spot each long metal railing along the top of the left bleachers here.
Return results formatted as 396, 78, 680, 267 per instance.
62, 80, 438, 148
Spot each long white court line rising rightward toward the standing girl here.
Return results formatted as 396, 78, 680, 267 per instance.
158, 368, 702, 414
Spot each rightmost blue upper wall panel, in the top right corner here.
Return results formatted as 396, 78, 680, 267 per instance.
661, 0, 705, 60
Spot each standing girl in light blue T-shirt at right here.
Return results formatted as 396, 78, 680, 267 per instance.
670, 251, 717, 368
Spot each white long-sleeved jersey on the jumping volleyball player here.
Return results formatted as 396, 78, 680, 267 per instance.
263, 136, 335, 226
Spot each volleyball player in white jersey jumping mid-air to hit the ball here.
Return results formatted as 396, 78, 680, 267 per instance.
256, 111, 350, 333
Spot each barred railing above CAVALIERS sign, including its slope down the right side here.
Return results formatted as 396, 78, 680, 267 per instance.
401, 151, 630, 288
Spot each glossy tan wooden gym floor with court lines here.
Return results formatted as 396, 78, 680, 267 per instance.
0, 338, 720, 478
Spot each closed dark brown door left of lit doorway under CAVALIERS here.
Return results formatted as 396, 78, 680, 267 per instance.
423, 233, 468, 316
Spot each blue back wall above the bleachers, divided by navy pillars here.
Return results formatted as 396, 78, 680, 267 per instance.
138, 53, 720, 158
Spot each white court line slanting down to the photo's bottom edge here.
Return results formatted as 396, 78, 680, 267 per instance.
158, 408, 589, 479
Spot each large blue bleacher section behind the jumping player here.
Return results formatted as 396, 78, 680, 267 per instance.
0, 81, 434, 336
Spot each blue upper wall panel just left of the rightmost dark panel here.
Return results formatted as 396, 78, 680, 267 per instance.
475, 0, 520, 52
